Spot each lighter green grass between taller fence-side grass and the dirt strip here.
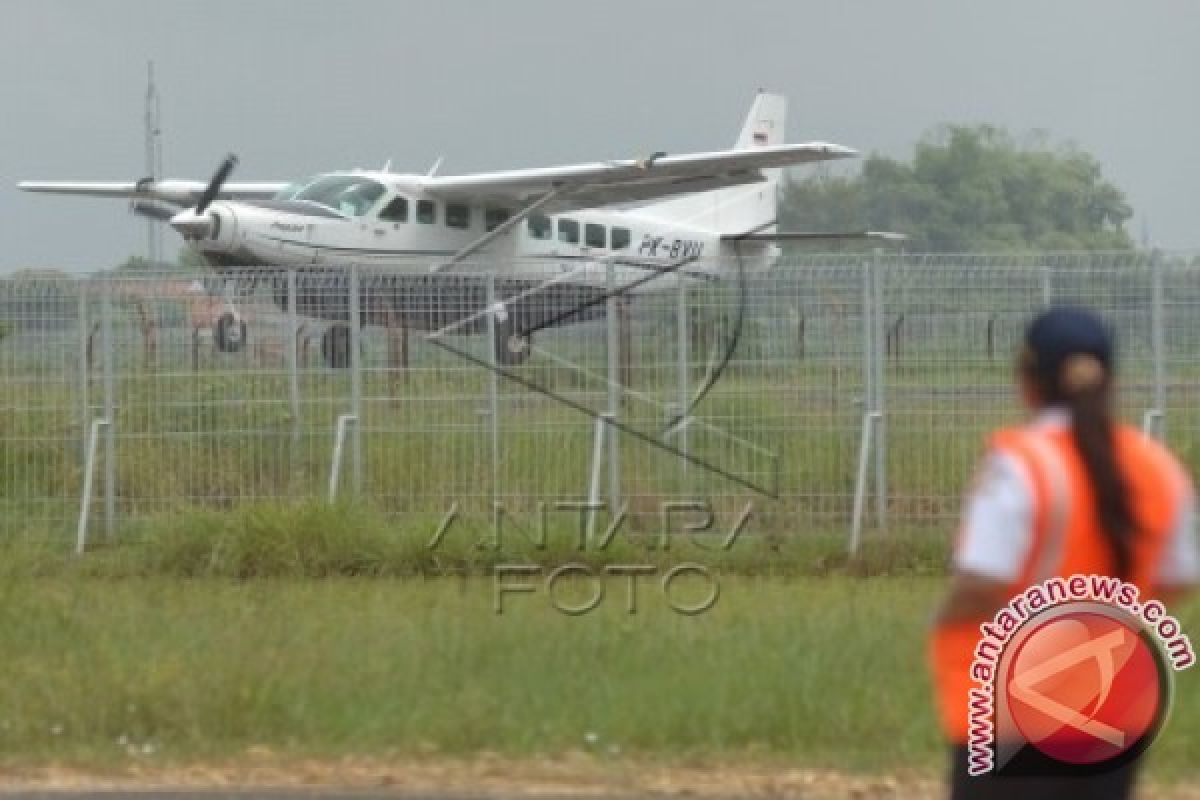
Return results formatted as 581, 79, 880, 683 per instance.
0, 578, 1200, 780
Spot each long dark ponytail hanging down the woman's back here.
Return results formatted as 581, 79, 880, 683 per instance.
1036, 354, 1138, 581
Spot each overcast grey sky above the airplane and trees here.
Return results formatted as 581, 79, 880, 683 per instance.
0, 0, 1200, 271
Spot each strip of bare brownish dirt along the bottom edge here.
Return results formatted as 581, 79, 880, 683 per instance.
0, 751, 1200, 800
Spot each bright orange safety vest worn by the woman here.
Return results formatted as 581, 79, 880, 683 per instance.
929, 426, 1192, 744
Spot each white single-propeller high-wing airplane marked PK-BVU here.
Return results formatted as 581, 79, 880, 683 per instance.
18, 92, 887, 365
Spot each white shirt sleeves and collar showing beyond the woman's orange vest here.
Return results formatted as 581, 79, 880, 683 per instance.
954, 409, 1200, 587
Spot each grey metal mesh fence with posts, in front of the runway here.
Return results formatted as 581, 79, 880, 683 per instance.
0, 253, 1200, 546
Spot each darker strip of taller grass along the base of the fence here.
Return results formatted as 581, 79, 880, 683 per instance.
0, 500, 947, 579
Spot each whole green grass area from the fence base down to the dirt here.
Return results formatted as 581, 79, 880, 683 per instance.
0, 504, 1200, 781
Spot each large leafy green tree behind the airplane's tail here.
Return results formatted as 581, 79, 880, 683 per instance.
780, 126, 1133, 252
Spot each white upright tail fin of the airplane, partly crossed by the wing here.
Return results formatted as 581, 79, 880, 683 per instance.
644, 91, 787, 234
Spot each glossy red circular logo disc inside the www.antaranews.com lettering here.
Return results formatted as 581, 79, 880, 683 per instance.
1004, 609, 1169, 765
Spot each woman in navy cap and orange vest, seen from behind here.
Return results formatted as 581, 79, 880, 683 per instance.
930, 308, 1200, 800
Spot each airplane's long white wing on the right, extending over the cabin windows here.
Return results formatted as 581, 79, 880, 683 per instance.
422, 142, 858, 212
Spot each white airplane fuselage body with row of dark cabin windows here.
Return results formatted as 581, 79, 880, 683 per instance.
188, 173, 775, 290
